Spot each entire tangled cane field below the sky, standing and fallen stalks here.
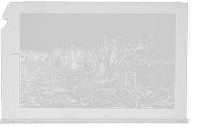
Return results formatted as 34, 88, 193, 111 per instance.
20, 32, 175, 109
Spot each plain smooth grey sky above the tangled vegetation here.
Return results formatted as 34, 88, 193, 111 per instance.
20, 13, 176, 58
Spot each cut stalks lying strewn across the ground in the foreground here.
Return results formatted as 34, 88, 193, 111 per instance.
20, 60, 174, 108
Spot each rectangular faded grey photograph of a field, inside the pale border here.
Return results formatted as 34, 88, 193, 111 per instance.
1, 4, 186, 121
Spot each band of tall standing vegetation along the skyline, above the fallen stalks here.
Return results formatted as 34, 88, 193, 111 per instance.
20, 32, 172, 70
